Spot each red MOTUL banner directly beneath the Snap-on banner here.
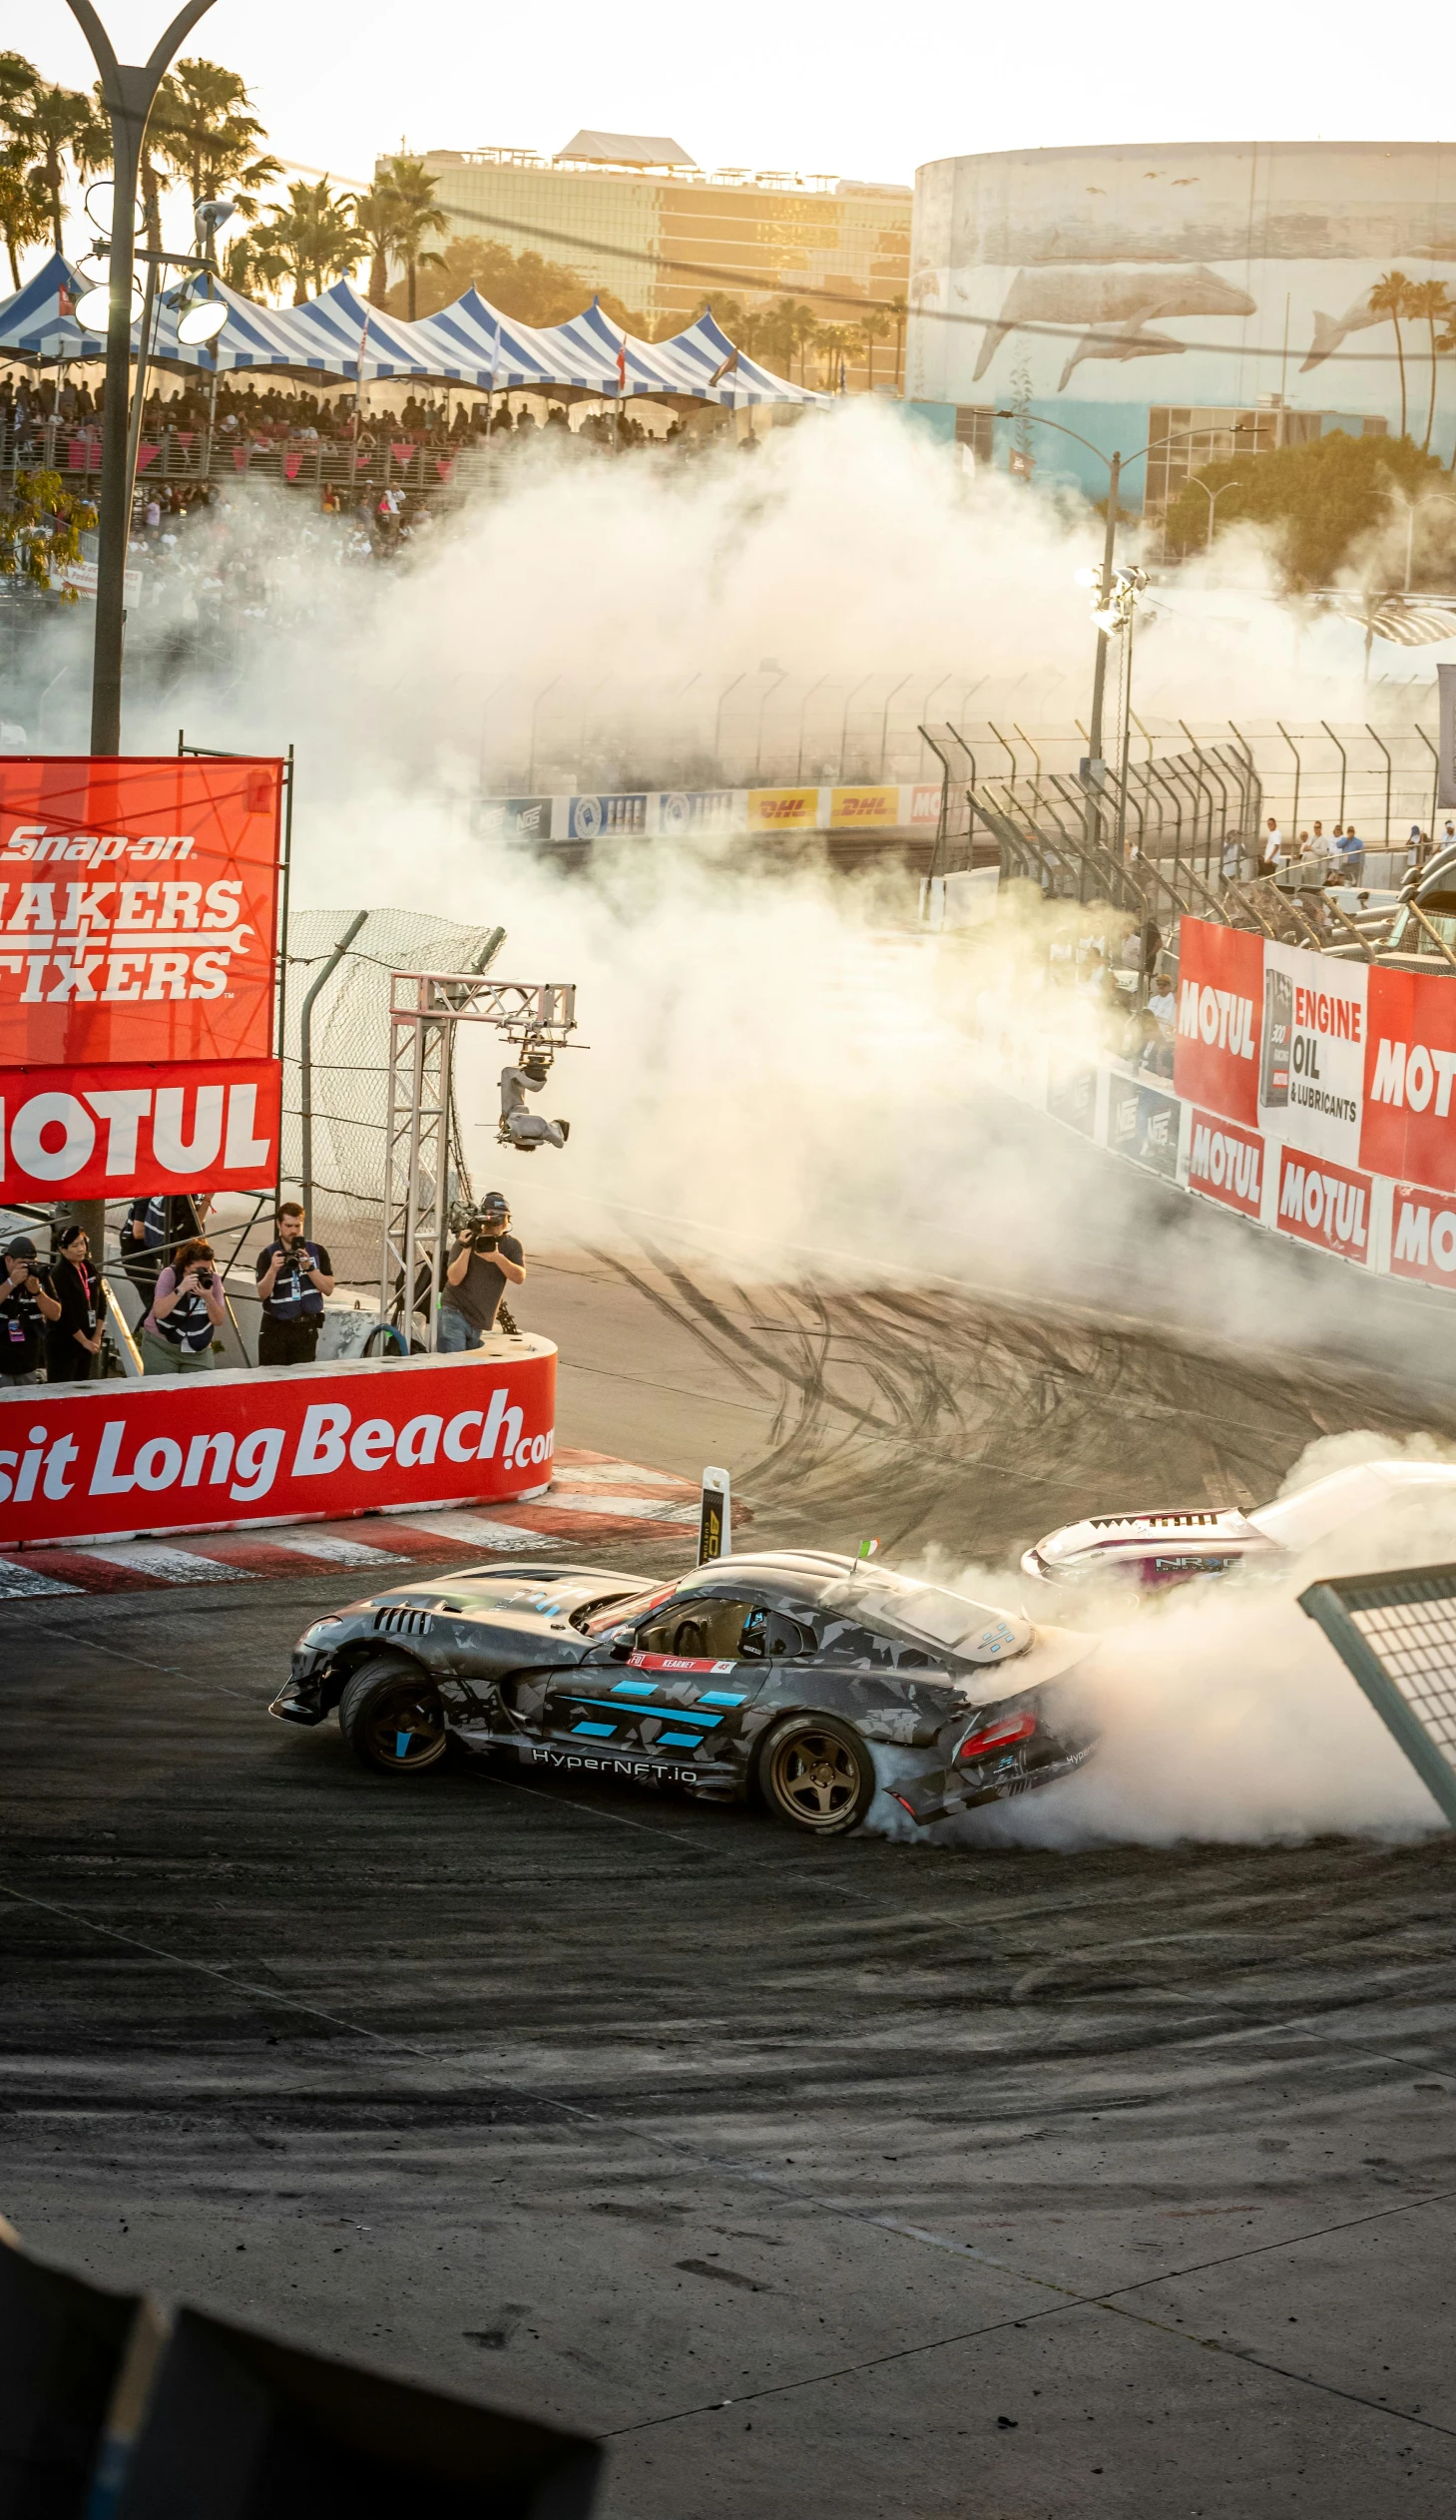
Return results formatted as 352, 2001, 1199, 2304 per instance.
0, 1059, 282, 1202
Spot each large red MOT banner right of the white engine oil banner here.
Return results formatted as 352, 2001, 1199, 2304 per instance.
1360, 968, 1456, 1190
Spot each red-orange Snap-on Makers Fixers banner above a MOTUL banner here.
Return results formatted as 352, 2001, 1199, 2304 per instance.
0, 754, 282, 1066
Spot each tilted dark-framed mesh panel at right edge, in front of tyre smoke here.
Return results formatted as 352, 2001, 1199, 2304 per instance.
1299, 1565, 1456, 1827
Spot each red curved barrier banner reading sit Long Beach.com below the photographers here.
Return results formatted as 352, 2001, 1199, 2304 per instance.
0, 1338, 557, 1547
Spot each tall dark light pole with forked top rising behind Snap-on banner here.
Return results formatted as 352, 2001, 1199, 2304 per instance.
68, 0, 212, 754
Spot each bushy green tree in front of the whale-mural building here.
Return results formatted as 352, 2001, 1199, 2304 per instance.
1164, 428, 1446, 590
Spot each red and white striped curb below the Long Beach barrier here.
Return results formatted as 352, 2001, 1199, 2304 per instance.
0, 1451, 725, 1600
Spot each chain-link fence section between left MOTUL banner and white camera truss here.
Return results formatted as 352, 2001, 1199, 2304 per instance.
282, 910, 501, 1287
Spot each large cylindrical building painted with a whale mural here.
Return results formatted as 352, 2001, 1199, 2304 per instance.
907, 141, 1456, 509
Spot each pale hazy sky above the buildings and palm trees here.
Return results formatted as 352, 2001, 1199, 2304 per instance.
19, 0, 1448, 202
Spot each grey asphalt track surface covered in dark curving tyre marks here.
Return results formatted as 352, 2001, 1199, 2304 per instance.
0, 1245, 1456, 2520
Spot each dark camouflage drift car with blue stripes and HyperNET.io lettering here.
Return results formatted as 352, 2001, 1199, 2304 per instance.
272, 1550, 1096, 1837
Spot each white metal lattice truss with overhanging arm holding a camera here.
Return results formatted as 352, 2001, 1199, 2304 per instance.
380, 970, 577, 1353
